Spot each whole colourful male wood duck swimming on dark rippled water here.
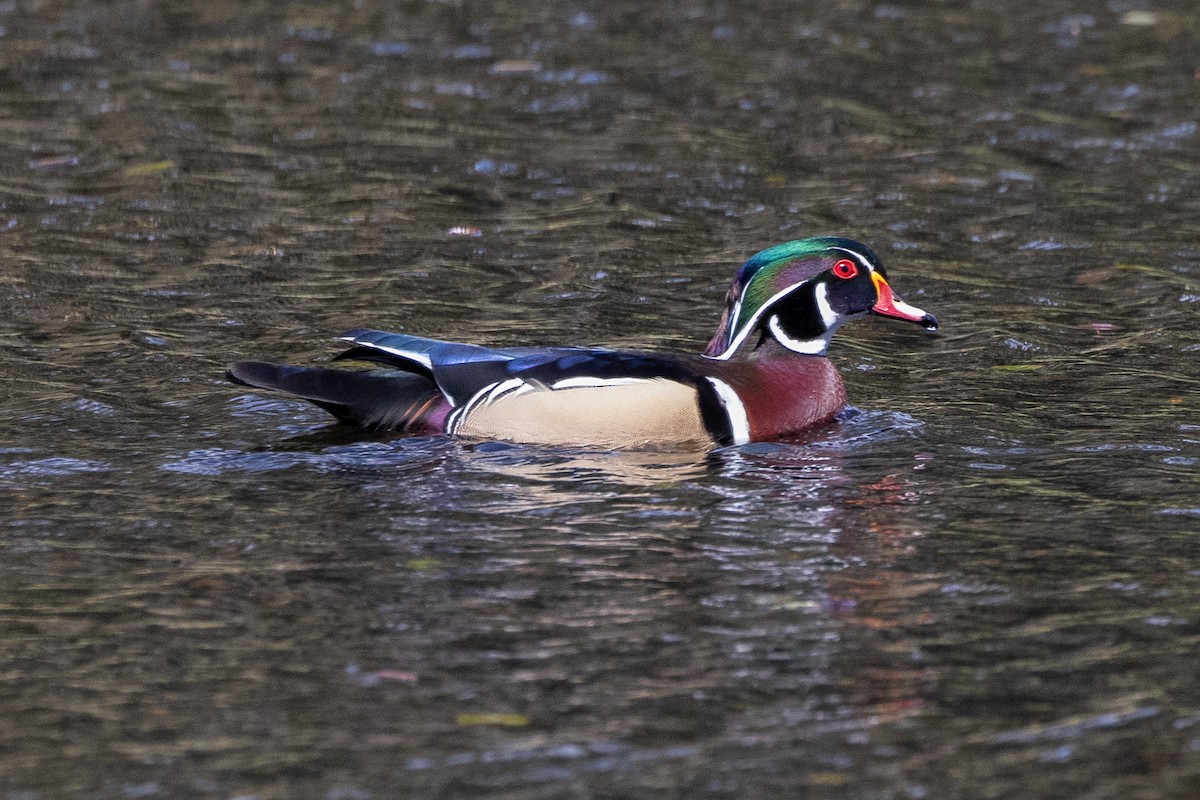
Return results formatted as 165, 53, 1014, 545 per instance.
228, 236, 937, 449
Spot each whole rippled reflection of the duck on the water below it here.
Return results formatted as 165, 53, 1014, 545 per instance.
218, 415, 946, 753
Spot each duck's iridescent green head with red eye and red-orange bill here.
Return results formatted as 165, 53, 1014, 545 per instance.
704, 236, 937, 360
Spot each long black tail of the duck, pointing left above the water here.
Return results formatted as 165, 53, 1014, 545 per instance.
226, 361, 442, 431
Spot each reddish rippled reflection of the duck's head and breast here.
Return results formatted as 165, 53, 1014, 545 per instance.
724, 439, 944, 724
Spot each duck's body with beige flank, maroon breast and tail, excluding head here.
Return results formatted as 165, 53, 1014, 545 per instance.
229, 331, 846, 447
